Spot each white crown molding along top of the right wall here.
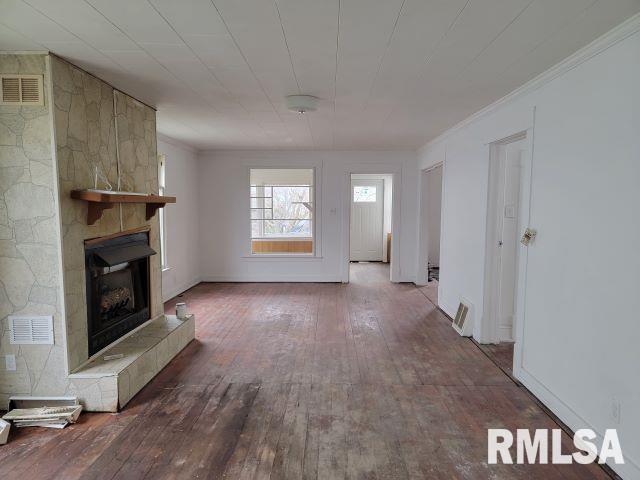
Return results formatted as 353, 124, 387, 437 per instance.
417, 13, 640, 153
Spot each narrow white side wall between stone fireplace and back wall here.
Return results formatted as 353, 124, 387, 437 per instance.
158, 135, 200, 301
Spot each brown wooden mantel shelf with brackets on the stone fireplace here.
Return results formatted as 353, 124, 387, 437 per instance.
71, 190, 176, 225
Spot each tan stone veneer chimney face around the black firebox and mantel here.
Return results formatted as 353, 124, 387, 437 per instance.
51, 56, 162, 370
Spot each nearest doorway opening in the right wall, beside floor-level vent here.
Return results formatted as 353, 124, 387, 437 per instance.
479, 132, 531, 361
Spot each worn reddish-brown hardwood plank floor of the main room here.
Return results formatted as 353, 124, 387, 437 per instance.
0, 264, 607, 480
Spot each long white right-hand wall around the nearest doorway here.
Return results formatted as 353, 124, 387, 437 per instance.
418, 17, 640, 478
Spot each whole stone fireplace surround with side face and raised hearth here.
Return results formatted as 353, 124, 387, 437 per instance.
0, 54, 194, 411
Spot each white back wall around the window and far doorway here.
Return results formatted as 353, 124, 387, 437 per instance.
199, 151, 417, 282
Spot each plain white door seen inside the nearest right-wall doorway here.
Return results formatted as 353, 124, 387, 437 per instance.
496, 140, 526, 341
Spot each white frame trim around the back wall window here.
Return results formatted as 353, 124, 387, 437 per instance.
245, 165, 320, 259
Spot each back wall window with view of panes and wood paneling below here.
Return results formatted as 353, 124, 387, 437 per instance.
249, 168, 314, 255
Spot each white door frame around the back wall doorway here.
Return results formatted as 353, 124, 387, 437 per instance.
340, 168, 402, 283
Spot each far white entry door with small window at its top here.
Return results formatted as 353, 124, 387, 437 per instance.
350, 179, 384, 261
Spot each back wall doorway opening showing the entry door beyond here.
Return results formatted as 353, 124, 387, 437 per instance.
349, 174, 393, 279
